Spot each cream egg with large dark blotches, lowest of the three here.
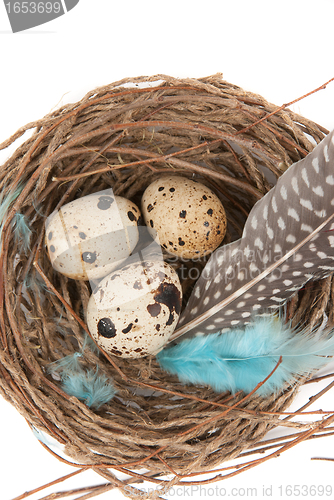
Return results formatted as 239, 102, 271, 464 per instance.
86, 260, 182, 358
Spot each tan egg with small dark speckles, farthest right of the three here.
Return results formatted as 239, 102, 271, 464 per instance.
141, 175, 226, 259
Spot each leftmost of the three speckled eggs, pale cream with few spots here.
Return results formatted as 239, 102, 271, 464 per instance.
45, 189, 140, 280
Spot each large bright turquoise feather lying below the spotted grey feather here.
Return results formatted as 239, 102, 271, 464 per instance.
157, 316, 334, 396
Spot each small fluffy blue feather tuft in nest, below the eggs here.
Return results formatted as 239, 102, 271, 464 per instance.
63, 370, 117, 409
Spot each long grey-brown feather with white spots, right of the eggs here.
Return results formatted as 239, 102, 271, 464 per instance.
170, 131, 334, 341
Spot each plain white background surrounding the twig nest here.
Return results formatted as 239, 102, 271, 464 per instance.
0, 0, 334, 500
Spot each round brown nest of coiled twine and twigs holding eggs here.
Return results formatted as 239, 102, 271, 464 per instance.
0, 74, 333, 497
